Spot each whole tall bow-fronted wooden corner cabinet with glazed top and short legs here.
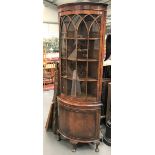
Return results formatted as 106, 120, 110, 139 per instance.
57, 3, 107, 152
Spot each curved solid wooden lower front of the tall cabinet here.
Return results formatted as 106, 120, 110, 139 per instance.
59, 105, 99, 139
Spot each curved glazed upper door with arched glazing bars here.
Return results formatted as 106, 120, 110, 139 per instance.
60, 14, 102, 101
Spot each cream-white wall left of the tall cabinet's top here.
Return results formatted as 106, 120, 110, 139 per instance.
43, 4, 59, 38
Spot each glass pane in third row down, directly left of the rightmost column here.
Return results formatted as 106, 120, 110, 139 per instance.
77, 61, 87, 80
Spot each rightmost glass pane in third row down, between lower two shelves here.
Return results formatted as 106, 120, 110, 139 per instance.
88, 62, 98, 80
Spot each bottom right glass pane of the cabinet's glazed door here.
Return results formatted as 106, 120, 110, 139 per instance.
87, 82, 97, 99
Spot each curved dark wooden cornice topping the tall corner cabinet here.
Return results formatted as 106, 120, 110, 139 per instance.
58, 2, 108, 12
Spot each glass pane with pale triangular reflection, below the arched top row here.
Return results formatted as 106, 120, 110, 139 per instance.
67, 39, 77, 60
